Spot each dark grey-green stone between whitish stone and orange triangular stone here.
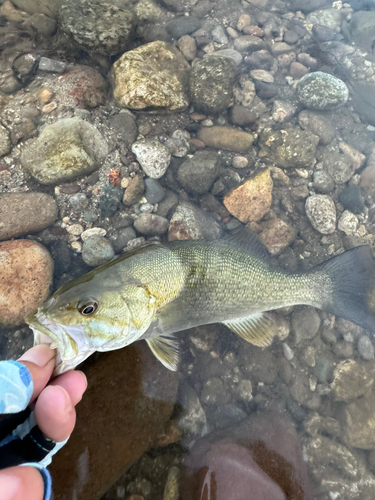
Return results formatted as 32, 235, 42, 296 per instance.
177, 151, 221, 195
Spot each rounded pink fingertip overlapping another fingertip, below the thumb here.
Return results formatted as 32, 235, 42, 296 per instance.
35, 385, 76, 442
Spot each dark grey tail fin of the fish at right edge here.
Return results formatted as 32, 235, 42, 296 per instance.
313, 246, 375, 333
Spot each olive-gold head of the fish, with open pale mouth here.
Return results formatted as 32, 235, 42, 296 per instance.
26, 273, 156, 374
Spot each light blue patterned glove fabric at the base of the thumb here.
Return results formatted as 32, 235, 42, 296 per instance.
0, 361, 34, 413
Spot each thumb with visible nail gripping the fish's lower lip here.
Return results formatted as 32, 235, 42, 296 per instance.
18, 344, 56, 401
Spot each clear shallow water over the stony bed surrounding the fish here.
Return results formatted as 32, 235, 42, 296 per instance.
0, 0, 375, 500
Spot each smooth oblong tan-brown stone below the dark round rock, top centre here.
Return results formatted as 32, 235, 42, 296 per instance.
198, 126, 254, 153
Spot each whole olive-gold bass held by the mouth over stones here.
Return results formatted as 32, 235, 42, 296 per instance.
26, 230, 375, 374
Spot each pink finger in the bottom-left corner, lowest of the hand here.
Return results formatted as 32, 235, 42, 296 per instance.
0, 467, 44, 500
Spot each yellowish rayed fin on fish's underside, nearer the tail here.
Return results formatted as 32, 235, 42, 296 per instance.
223, 313, 275, 347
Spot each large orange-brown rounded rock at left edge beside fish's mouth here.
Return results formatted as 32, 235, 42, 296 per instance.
0, 240, 53, 326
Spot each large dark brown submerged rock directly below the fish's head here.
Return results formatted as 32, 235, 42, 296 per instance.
50, 342, 178, 500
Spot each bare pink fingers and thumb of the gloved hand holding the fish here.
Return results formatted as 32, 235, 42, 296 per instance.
0, 344, 87, 500
